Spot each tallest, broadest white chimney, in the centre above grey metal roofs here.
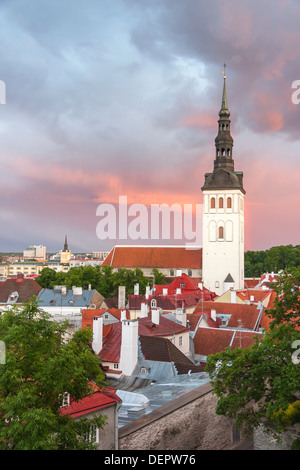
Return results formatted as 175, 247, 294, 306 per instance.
120, 320, 139, 377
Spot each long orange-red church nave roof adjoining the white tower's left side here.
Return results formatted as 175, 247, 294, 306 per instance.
102, 246, 202, 269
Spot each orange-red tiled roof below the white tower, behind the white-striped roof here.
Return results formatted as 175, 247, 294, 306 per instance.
194, 302, 260, 330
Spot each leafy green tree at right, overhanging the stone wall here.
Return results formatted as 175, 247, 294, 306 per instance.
206, 268, 300, 448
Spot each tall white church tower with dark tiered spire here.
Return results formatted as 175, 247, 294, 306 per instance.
201, 72, 245, 295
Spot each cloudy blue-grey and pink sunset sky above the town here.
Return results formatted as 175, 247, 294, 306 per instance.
0, 0, 300, 252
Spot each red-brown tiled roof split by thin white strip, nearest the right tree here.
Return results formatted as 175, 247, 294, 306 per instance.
193, 328, 259, 356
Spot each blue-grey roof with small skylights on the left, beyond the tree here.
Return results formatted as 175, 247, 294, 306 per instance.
38, 289, 96, 307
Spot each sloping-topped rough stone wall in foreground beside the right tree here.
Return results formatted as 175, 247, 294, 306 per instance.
119, 383, 239, 450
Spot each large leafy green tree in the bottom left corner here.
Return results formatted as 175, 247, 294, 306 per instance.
0, 300, 105, 450
